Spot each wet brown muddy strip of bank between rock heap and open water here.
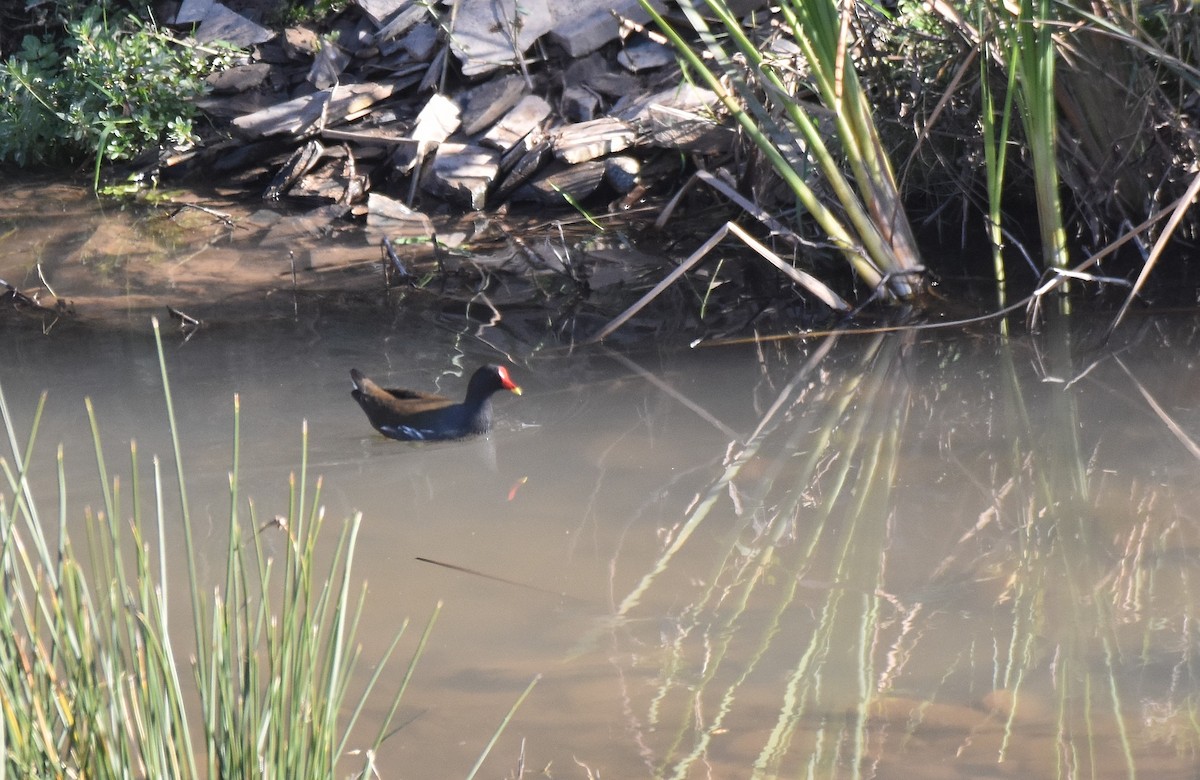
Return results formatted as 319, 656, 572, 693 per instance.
0, 180, 720, 343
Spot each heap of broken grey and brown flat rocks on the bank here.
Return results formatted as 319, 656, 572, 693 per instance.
175, 0, 732, 236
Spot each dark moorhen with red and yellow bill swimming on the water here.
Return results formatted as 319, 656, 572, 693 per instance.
350, 366, 521, 442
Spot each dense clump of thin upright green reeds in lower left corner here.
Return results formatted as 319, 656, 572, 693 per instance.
0, 323, 422, 780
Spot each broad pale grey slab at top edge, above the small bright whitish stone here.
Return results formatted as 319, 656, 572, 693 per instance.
450, 0, 554, 77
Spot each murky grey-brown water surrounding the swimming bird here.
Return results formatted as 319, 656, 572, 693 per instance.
0, 183, 1200, 778
